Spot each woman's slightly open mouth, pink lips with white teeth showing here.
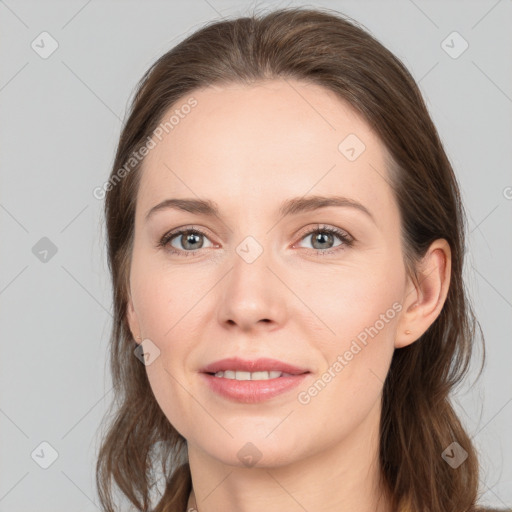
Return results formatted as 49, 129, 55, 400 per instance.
200, 358, 311, 403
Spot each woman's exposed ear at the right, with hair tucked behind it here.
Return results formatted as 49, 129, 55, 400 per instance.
395, 239, 451, 348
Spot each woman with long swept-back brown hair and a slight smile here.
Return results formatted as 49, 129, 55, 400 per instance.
97, 8, 504, 512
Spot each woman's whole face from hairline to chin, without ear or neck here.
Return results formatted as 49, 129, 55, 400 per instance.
128, 80, 410, 466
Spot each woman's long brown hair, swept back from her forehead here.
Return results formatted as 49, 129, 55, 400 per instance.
96, 8, 485, 512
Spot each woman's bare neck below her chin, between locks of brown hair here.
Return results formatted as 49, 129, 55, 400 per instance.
187, 400, 391, 512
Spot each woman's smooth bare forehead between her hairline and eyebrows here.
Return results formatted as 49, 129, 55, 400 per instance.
138, 79, 393, 223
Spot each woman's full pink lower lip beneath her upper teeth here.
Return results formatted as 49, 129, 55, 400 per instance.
201, 373, 308, 404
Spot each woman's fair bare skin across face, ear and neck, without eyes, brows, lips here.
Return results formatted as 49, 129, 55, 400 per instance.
127, 80, 450, 512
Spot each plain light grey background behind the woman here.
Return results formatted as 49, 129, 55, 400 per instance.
0, 0, 512, 512
